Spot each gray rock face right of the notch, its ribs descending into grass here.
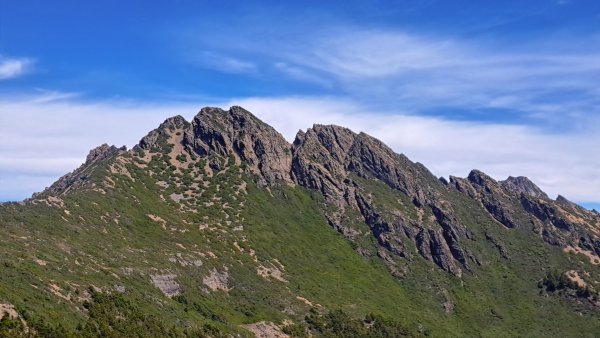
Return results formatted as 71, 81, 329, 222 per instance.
292, 125, 468, 275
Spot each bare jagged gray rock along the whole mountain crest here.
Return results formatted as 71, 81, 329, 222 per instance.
37, 106, 596, 276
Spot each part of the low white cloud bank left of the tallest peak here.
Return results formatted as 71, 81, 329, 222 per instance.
0, 92, 197, 200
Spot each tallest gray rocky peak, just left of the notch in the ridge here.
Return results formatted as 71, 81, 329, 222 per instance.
138, 106, 292, 184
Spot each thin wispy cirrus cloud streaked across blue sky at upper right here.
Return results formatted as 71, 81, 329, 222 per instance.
176, 26, 600, 128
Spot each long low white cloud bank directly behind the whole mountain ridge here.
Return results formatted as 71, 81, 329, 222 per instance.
0, 97, 600, 206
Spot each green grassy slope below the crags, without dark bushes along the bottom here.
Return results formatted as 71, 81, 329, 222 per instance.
0, 152, 600, 336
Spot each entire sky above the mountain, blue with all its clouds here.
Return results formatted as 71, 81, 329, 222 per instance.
0, 0, 600, 210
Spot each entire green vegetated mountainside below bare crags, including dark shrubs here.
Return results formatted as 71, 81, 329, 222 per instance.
0, 141, 600, 337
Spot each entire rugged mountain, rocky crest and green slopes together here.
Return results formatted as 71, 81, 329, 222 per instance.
0, 107, 600, 337
